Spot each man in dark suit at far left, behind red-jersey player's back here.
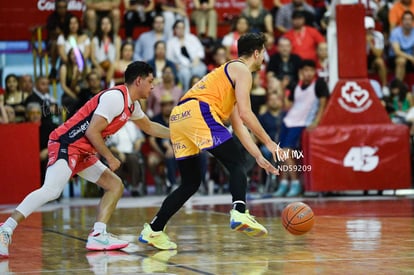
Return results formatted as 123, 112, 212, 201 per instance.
25, 76, 60, 125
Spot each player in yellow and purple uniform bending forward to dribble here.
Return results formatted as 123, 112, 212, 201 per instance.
139, 33, 280, 249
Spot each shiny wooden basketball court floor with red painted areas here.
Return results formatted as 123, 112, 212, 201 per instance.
0, 195, 414, 275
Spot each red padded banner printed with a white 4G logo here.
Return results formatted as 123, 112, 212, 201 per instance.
303, 123, 411, 191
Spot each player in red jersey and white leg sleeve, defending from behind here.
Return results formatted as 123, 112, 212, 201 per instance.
0, 61, 170, 257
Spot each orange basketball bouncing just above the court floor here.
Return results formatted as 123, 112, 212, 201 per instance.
282, 202, 315, 235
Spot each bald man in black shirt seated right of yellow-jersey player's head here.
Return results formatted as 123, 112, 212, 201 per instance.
266, 37, 302, 87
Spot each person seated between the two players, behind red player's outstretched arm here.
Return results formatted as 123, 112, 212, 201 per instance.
149, 92, 178, 193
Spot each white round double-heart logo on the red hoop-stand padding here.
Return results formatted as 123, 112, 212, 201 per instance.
338, 81, 372, 113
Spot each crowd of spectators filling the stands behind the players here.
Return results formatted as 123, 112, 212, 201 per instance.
0, 0, 414, 196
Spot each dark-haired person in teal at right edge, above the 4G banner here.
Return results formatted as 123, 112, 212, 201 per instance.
388, 79, 414, 123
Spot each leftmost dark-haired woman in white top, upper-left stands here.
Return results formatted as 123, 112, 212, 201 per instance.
57, 15, 91, 63
